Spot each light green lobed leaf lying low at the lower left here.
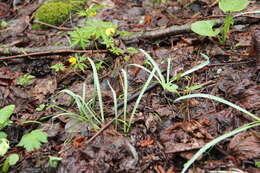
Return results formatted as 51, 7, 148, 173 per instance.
17, 129, 48, 152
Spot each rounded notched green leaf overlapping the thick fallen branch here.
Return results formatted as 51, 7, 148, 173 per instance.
191, 20, 220, 37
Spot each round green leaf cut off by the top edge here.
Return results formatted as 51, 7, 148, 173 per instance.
218, 0, 249, 12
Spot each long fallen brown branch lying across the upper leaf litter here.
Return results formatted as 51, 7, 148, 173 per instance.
0, 17, 259, 60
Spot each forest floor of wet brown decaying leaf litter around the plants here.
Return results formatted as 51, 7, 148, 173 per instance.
0, 0, 260, 173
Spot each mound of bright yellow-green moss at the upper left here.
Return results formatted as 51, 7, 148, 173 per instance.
33, 2, 73, 29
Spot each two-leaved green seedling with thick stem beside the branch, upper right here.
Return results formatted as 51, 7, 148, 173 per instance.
191, 0, 249, 44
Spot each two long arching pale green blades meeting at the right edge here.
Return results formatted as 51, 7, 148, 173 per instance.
175, 94, 260, 173
